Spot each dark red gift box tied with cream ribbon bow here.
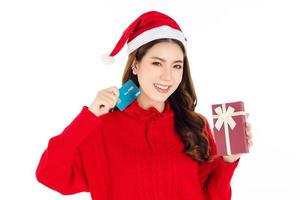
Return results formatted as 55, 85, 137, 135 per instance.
211, 101, 249, 156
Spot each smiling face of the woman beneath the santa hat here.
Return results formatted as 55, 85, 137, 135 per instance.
136, 42, 184, 108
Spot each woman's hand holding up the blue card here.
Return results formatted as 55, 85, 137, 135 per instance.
89, 87, 119, 117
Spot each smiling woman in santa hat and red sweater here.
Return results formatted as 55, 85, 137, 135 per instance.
36, 11, 252, 200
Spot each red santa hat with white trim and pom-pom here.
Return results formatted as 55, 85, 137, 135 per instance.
102, 11, 187, 64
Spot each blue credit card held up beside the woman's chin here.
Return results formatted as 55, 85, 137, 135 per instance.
116, 79, 141, 111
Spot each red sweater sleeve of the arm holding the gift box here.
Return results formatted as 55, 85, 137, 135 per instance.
204, 116, 239, 200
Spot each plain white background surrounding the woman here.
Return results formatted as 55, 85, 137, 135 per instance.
0, 0, 300, 200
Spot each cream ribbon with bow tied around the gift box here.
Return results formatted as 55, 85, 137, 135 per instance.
213, 104, 245, 155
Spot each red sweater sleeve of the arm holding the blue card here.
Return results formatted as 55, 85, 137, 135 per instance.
35, 106, 99, 194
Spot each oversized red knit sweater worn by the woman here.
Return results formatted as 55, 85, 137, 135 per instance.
36, 100, 239, 200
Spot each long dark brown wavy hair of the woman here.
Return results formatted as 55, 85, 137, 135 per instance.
122, 38, 212, 164
